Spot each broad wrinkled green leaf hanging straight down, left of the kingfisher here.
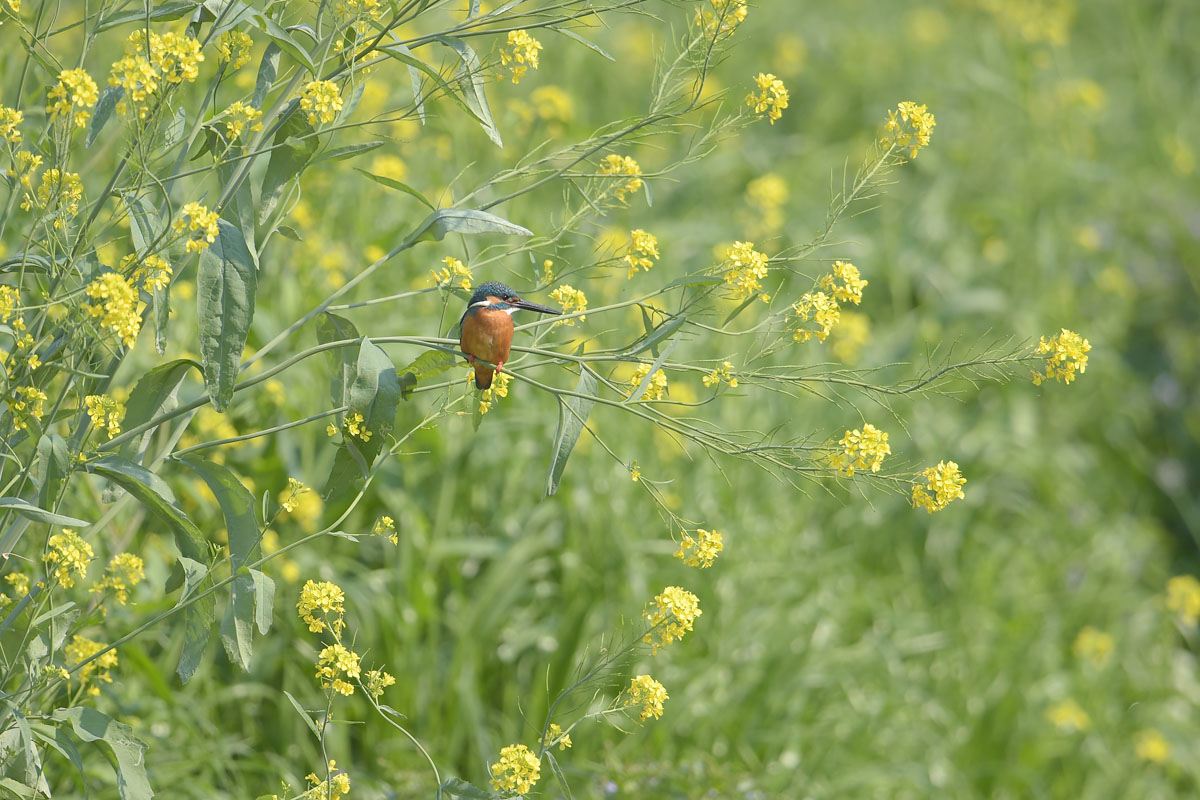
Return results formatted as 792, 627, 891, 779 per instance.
196, 219, 258, 411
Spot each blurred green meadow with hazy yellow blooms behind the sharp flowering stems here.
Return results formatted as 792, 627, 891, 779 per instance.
37, 0, 1200, 800
